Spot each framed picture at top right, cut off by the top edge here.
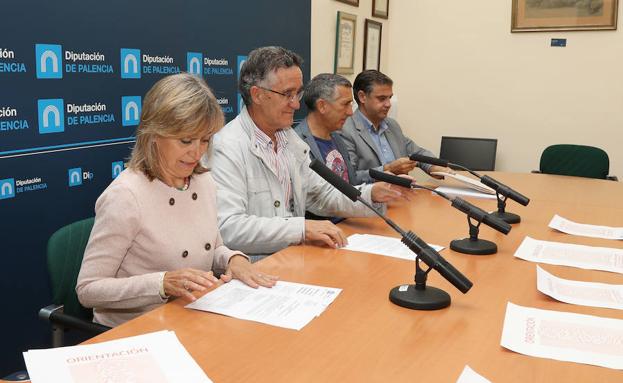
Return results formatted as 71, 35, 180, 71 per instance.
511, 0, 619, 32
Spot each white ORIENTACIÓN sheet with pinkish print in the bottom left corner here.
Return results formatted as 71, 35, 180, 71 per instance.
24, 331, 211, 383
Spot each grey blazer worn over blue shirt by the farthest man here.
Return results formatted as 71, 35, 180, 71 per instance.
340, 110, 436, 184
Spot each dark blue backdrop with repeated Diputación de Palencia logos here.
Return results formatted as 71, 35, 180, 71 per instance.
0, 0, 311, 377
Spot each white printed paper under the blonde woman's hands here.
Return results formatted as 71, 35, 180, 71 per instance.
185, 279, 342, 330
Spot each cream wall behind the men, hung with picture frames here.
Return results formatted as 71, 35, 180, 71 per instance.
312, 0, 623, 176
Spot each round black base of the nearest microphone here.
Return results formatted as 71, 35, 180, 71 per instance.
389, 285, 450, 310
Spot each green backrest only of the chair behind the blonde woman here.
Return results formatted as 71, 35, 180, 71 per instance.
47, 217, 95, 321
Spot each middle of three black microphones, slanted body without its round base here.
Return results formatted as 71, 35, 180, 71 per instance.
368, 169, 511, 234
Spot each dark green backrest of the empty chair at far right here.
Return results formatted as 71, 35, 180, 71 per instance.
539, 144, 610, 179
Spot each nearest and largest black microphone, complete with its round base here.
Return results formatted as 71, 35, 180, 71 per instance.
309, 159, 473, 310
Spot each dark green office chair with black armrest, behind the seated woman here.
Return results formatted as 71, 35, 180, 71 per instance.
39, 217, 110, 347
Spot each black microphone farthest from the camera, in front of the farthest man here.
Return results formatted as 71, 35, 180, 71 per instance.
409, 153, 530, 223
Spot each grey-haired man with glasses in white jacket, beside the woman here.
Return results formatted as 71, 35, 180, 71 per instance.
209, 47, 402, 260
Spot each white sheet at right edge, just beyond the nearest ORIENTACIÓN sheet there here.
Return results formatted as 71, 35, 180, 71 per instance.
536, 266, 623, 312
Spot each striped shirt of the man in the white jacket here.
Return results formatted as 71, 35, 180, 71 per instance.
254, 127, 292, 212
